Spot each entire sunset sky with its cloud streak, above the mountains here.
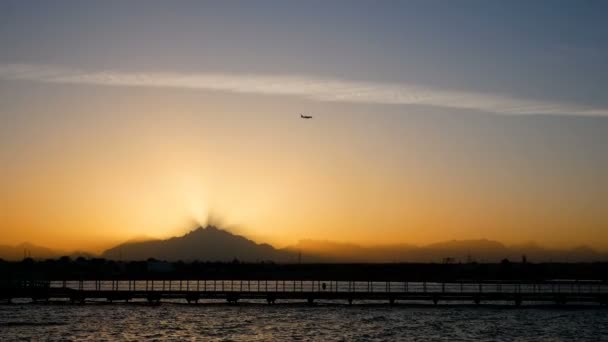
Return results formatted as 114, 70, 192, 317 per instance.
0, 0, 608, 251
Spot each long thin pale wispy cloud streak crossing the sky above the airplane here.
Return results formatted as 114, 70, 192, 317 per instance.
0, 64, 608, 116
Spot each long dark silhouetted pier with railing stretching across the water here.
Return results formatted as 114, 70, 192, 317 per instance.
0, 279, 608, 306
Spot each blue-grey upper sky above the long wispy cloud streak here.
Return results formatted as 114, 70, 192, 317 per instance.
0, 1, 608, 106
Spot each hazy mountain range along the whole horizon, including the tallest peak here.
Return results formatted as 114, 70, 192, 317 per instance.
0, 225, 608, 263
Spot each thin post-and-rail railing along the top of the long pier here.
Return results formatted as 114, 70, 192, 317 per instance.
36, 280, 608, 293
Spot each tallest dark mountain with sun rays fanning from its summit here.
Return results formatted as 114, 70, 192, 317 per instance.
102, 226, 297, 262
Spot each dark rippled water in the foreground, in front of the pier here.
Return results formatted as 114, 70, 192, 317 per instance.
0, 303, 608, 341
